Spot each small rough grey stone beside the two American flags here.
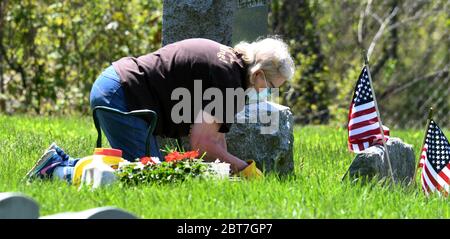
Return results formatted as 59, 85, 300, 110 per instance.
349, 137, 415, 183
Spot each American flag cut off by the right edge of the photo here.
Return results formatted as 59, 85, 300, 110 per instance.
419, 120, 450, 195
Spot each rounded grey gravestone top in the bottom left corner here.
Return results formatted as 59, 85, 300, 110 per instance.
0, 193, 39, 219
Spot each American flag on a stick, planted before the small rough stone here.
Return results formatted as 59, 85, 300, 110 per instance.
348, 66, 389, 153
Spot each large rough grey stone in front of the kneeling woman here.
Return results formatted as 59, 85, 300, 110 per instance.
226, 102, 294, 174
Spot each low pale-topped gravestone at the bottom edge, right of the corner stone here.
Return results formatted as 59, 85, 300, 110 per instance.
40, 207, 137, 219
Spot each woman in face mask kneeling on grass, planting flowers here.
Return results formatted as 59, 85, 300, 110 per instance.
29, 38, 294, 180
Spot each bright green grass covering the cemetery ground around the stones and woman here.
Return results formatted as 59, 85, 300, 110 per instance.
0, 115, 450, 218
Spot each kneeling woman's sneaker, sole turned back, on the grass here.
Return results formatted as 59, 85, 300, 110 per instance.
25, 149, 62, 179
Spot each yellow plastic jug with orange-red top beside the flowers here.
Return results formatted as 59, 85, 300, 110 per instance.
72, 148, 126, 186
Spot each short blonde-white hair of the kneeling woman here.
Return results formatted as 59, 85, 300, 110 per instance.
234, 37, 295, 81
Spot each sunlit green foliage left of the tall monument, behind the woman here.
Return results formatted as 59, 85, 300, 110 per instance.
0, 0, 162, 113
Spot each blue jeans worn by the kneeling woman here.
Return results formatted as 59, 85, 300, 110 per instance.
90, 66, 164, 161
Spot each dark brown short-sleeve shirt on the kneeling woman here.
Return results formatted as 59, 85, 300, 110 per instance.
112, 38, 247, 138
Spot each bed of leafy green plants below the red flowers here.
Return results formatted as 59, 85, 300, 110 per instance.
117, 159, 213, 186
